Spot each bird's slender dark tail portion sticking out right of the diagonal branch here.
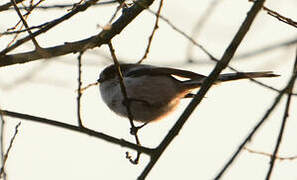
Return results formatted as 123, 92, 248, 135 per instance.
218, 71, 279, 82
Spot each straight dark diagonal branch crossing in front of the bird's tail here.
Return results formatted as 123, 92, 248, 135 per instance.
138, 0, 264, 179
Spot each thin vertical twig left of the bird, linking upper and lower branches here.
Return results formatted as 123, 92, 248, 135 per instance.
76, 51, 84, 127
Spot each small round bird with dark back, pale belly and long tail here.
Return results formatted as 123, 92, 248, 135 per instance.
97, 63, 279, 123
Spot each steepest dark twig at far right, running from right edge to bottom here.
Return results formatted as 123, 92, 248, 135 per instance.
266, 48, 297, 180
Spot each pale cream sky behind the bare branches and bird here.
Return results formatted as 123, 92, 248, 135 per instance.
0, 0, 297, 180
